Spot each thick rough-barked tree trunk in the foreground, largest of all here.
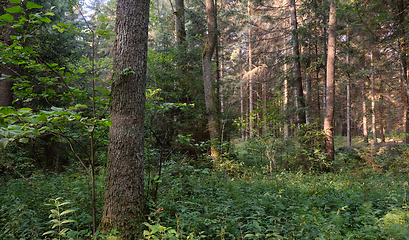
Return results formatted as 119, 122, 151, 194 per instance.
102, 0, 149, 239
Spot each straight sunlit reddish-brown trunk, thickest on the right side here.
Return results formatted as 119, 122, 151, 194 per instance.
324, 0, 336, 160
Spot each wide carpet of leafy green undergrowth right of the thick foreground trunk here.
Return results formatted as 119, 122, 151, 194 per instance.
151, 169, 408, 239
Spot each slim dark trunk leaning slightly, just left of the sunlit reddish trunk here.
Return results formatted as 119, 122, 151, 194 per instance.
289, 0, 306, 125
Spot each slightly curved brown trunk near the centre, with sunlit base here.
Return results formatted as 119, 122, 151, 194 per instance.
202, 0, 219, 161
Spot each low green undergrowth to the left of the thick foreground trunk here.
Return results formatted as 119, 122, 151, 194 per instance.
0, 170, 105, 240
